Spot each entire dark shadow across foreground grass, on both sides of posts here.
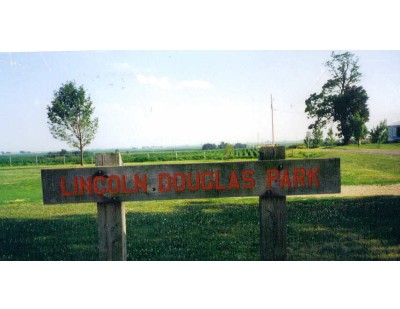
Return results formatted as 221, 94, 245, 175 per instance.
0, 196, 400, 261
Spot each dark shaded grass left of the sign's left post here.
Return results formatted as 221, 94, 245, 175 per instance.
0, 215, 99, 261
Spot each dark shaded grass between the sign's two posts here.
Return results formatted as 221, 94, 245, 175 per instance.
127, 200, 259, 261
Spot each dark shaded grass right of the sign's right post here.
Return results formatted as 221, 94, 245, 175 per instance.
288, 196, 400, 261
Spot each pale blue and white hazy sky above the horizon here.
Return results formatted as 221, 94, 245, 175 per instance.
0, 50, 400, 152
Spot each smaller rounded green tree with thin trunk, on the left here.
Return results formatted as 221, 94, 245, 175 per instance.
47, 82, 99, 165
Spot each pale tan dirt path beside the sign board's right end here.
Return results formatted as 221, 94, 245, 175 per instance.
294, 184, 400, 197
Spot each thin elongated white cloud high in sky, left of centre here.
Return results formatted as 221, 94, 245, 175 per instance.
136, 74, 211, 90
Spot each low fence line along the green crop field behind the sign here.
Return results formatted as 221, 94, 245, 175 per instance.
0, 148, 258, 166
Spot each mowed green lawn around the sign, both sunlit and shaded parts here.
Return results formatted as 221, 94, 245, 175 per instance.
0, 149, 400, 261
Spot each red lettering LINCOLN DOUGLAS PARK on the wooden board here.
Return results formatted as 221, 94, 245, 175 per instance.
55, 167, 320, 196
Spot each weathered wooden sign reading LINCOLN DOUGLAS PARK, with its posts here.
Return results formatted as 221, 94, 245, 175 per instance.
42, 147, 340, 260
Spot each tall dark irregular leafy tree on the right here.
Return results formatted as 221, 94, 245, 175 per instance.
305, 52, 369, 144
